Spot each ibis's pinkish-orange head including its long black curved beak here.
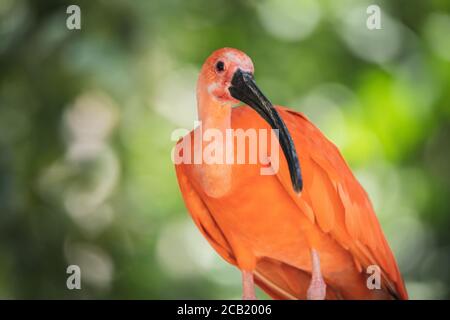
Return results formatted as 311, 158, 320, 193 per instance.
198, 48, 303, 193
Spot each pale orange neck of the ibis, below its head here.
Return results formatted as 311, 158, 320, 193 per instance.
196, 91, 233, 198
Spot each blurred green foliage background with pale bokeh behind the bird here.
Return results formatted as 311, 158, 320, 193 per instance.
0, 0, 450, 299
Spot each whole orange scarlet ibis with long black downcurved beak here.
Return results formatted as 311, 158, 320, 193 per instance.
174, 48, 408, 299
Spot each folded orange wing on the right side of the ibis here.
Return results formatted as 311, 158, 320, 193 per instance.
277, 107, 408, 299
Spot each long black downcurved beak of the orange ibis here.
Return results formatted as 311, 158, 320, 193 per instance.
228, 69, 303, 193
